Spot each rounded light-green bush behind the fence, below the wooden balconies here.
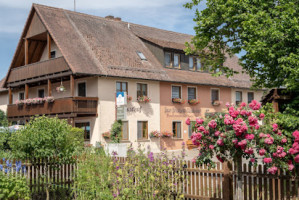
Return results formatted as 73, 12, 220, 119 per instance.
9, 116, 83, 162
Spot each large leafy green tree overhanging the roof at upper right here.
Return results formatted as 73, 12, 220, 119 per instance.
184, 0, 299, 89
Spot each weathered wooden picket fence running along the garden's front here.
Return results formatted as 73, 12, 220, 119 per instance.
0, 158, 299, 200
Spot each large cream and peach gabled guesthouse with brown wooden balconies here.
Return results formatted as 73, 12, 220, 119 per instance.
3, 4, 262, 150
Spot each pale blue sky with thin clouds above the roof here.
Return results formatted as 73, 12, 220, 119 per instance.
0, 0, 204, 78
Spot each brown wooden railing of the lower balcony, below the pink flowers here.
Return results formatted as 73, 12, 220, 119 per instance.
7, 97, 98, 119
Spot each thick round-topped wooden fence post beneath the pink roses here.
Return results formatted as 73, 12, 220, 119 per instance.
222, 161, 234, 200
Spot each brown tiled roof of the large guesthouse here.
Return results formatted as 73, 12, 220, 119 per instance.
33, 4, 251, 88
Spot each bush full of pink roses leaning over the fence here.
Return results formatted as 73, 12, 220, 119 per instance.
186, 100, 299, 174
